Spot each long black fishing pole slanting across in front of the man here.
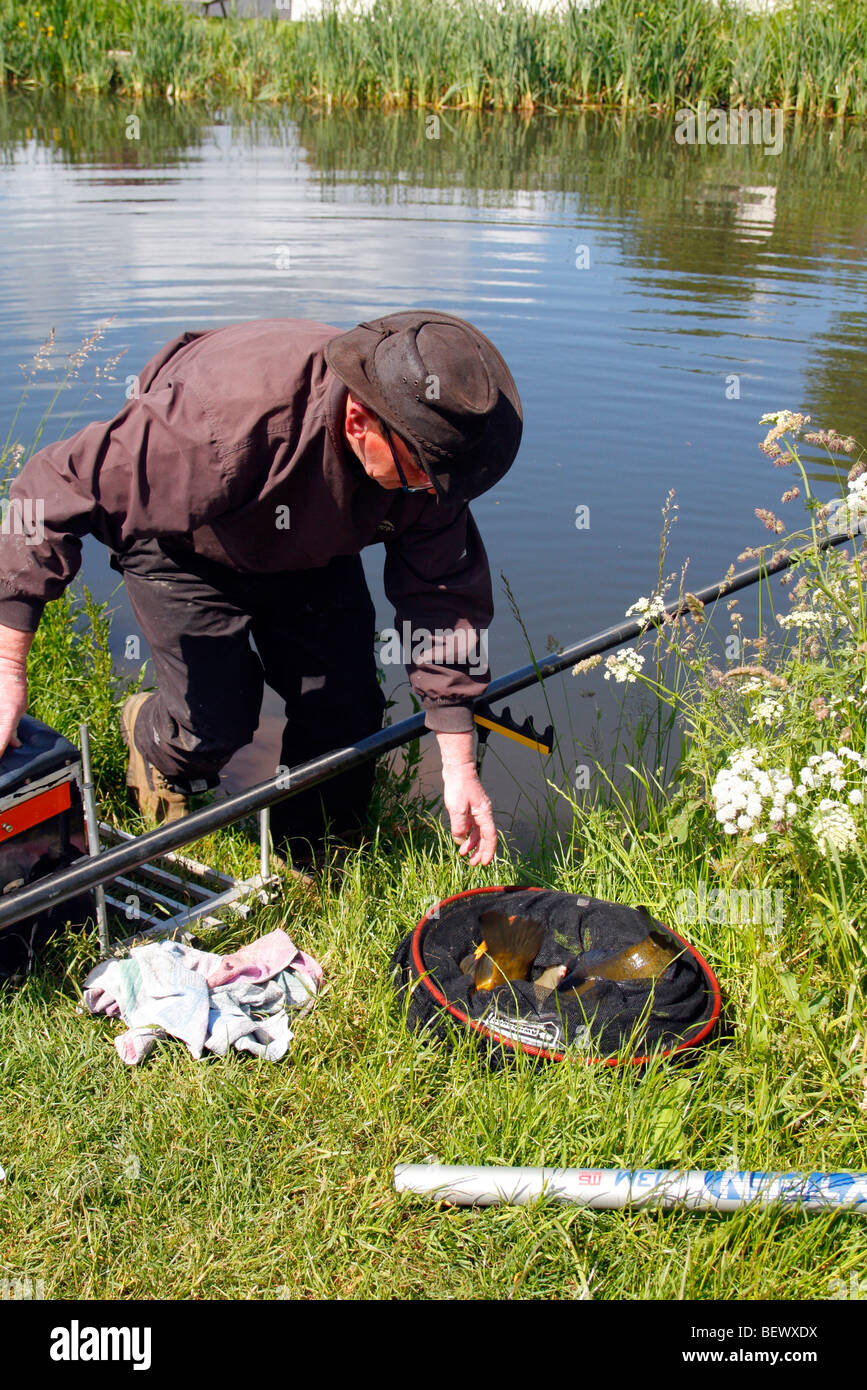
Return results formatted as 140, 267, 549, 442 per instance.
0, 532, 854, 929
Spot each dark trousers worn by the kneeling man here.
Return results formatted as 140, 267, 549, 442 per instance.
111, 541, 385, 852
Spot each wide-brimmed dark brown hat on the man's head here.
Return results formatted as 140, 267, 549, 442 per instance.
325, 309, 522, 502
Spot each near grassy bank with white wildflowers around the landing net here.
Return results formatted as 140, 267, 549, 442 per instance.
0, 339, 867, 1301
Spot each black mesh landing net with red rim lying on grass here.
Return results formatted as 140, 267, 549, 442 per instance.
392, 888, 718, 1065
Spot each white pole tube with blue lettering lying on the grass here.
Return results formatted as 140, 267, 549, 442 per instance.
395, 1163, 867, 1215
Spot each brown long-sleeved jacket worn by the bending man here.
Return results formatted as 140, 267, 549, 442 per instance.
0, 318, 493, 730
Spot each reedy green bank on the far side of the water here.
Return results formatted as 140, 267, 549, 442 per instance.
0, 0, 867, 115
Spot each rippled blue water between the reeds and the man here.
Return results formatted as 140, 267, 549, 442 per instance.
0, 96, 867, 842
